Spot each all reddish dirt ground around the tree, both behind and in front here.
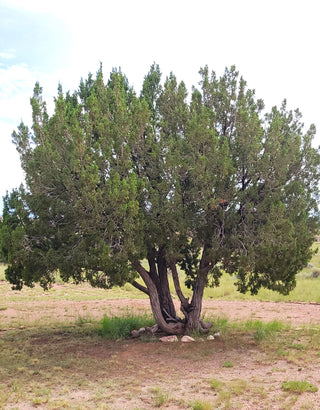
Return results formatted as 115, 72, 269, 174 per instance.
0, 284, 320, 410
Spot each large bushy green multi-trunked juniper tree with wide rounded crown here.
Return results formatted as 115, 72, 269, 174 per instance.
1, 64, 320, 333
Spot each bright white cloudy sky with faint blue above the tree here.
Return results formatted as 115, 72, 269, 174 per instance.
0, 0, 320, 213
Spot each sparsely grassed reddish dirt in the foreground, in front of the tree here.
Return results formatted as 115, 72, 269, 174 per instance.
0, 330, 320, 410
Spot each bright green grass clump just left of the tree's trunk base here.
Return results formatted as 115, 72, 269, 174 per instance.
100, 313, 154, 340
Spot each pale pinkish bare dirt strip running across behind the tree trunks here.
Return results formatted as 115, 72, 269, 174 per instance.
0, 299, 320, 327
